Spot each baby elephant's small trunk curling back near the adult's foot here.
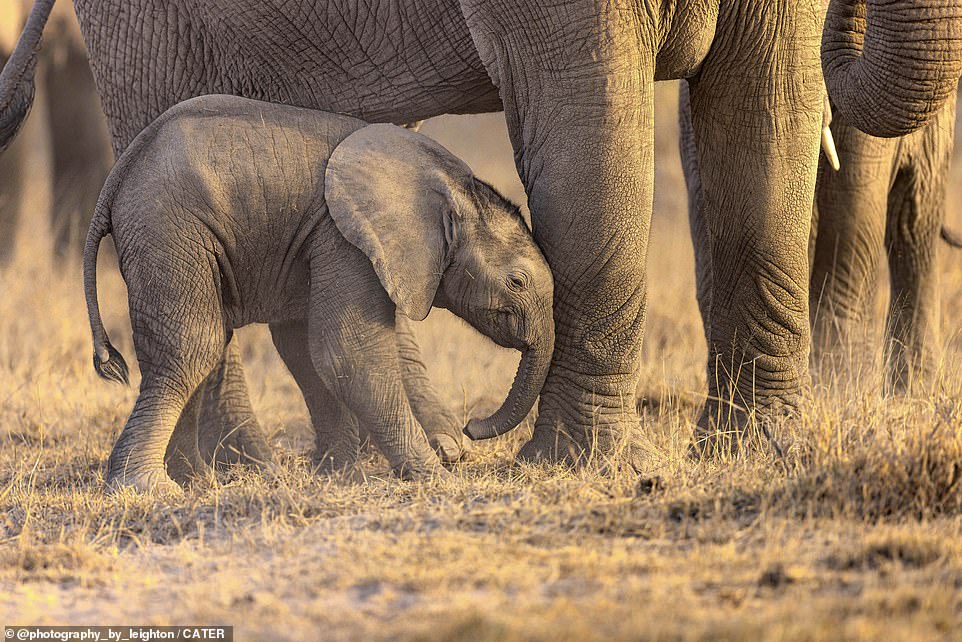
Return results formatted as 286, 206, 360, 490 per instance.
464, 336, 554, 440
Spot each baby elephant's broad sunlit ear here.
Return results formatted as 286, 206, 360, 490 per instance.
324, 124, 472, 321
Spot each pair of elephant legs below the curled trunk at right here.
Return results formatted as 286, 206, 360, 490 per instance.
811, 95, 956, 392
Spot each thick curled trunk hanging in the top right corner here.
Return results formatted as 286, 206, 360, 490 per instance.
822, 0, 962, 138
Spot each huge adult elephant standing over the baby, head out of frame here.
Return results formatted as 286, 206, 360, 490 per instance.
0, 0, 821, 460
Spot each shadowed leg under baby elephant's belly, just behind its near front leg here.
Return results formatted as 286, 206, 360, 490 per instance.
271, 321, 359, 472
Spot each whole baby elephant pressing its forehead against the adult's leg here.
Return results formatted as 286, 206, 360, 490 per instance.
84, 96, 554, 490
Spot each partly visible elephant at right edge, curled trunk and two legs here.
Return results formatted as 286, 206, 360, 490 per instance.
811, 0, 962, 391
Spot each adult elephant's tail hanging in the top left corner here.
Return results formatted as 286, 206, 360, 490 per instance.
0, 0, 54, 152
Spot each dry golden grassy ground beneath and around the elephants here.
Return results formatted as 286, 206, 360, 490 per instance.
0, 84, 962, 640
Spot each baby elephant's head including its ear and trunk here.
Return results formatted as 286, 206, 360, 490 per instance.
324, 125, 554, 439
